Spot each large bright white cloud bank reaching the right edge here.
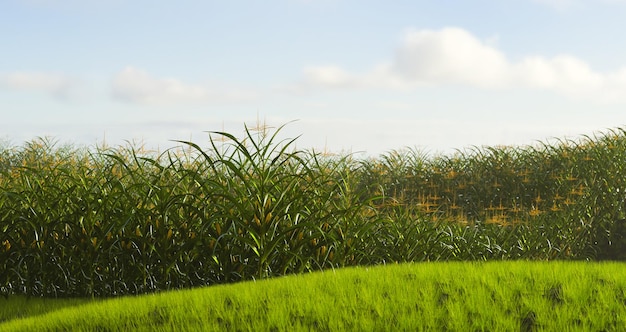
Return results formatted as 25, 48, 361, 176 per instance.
296, 28, 626, 102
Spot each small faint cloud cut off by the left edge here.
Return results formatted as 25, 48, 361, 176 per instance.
0, 72, 76, 99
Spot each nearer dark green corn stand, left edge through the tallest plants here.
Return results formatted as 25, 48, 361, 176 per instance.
0, 129, 376, 296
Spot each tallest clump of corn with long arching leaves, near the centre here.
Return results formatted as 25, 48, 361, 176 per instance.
173, 127, 367, 281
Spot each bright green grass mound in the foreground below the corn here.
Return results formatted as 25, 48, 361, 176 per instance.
0, 261, 626, 331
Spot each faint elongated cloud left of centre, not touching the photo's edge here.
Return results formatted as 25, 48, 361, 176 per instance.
112, 66, 254, 105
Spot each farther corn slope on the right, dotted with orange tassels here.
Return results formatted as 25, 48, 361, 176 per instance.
356, 129, 626, 259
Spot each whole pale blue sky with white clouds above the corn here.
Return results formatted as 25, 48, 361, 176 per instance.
0, 0, 626, 156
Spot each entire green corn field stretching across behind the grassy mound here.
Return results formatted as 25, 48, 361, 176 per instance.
0, 128, 626, 297
